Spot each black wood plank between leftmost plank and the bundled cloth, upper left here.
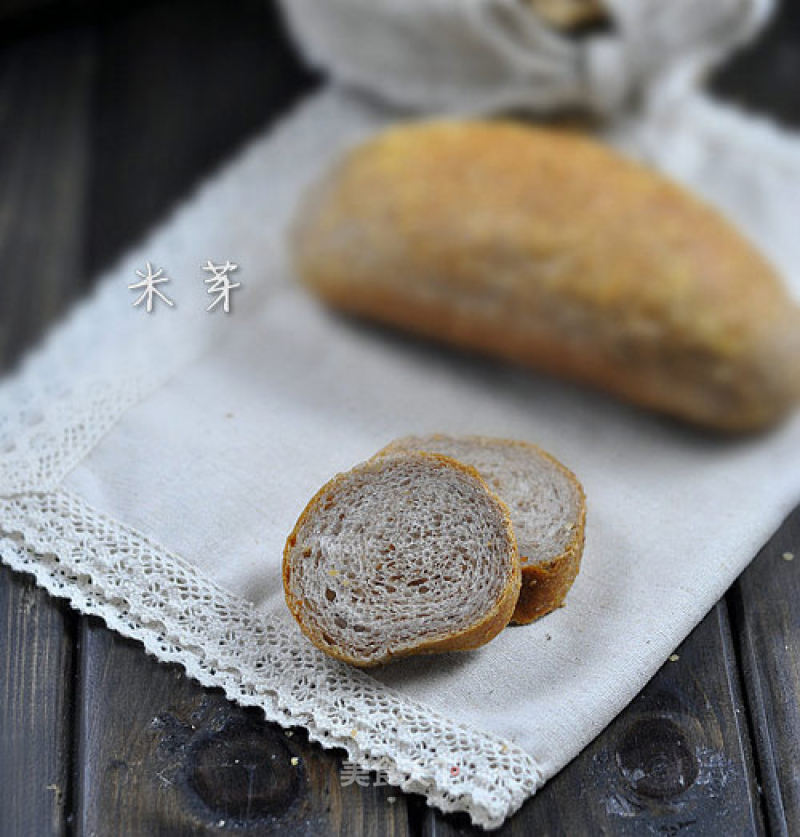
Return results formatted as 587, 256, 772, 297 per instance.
83, 0, 315, 271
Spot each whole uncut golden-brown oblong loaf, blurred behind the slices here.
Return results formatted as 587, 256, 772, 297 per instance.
292, 120, 800, 431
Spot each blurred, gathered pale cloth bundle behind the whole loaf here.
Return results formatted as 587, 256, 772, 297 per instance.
282, 0, 773, 116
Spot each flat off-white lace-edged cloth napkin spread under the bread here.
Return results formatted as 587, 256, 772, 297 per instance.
0, 0, 800, 828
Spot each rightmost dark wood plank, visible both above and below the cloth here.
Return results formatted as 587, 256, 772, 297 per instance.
713, 16, 800, 834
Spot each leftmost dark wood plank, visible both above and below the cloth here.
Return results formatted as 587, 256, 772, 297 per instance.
0, 22, 93, 835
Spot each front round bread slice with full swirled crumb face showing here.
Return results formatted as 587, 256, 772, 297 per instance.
283, 451, 520, 666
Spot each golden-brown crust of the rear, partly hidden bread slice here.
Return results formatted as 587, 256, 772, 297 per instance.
375, 433, 586, 625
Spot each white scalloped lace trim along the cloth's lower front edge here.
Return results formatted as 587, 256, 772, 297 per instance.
0, 491, 542, 828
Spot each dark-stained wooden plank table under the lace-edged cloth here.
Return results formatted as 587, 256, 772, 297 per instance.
0, 0, 800, 837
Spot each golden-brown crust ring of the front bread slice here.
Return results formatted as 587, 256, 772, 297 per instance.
282, 452, 521, 668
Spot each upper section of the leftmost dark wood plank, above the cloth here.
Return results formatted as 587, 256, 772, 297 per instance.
0, 27, 94, 368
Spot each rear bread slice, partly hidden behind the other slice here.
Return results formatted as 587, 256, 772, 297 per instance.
376, 434, 586, 623
